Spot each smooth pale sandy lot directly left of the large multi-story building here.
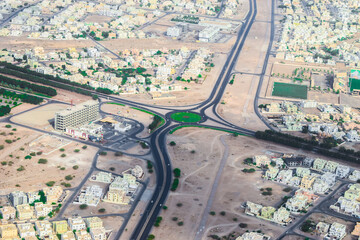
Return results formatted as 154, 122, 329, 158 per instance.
12, 104, 68, 129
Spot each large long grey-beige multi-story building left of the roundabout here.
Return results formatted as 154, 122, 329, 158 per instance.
55, 100, 99, 131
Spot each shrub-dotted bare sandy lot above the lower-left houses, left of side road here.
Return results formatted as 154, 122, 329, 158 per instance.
0, 124, 97, 194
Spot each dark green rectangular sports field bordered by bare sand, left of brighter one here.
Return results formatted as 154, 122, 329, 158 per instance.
272, 82, 307, 99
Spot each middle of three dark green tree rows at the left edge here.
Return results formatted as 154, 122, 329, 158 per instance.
0, 72, 57, 97
